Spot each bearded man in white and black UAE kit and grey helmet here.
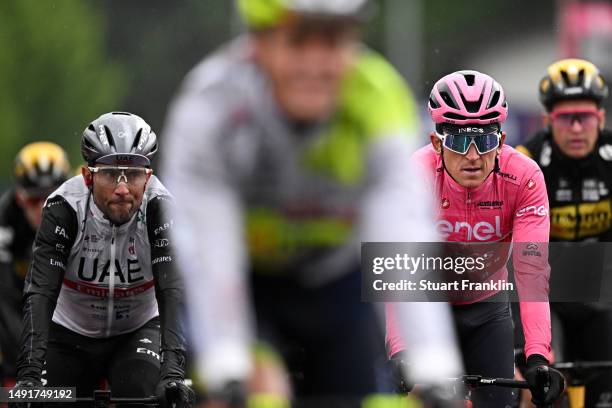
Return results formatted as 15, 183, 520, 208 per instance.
12, 112, 192, 407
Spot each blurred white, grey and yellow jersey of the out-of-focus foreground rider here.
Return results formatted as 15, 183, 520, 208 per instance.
162, 37, 462, 389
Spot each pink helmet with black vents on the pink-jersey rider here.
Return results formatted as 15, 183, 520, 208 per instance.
428, 71, 508, 125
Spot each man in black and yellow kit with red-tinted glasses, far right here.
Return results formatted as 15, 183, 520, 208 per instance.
517, 58, 612, 407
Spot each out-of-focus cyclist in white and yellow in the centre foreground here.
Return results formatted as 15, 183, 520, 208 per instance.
163, 0, 458, 404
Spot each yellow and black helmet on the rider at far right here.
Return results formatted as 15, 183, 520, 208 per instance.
540, 58, 608, 112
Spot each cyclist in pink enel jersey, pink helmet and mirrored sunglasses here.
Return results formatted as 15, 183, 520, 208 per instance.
387, 71, 565, 407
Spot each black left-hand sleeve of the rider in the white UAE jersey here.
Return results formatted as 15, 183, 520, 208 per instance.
17, 196, 78, 380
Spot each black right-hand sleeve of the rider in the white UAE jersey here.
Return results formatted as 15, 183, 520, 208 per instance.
147, 196, 186, 379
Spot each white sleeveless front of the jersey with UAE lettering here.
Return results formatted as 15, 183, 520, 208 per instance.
49, 176, 169, 337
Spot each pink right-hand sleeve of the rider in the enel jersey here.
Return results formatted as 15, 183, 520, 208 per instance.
512, 169, 551, 361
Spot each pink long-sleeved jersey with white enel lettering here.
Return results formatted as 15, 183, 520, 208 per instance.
387, 145, 551, 361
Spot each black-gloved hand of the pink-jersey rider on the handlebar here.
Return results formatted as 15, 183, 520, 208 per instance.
525, 354, 565, 405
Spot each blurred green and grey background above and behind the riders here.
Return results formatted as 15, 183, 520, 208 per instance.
0, 0, 610, 189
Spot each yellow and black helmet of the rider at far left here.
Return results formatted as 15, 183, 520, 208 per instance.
14, 142, 70, 195
